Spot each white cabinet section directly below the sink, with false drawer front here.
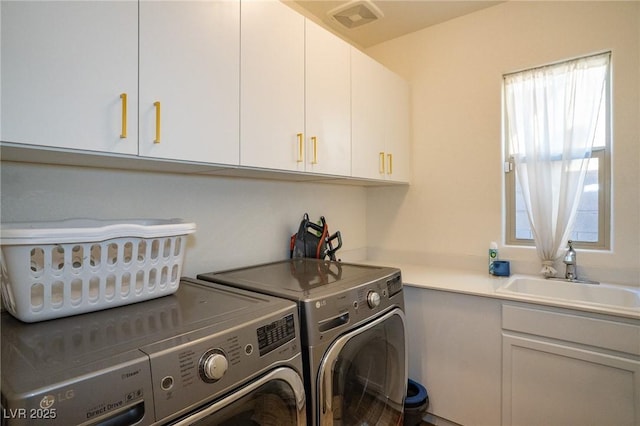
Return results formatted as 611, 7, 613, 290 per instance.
502, 305, 640, 426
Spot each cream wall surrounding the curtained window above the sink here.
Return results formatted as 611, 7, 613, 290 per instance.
367, 1, 640, 285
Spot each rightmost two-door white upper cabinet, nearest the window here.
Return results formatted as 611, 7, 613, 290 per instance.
351, 49, 410, 182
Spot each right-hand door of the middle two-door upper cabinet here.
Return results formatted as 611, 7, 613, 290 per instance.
305, 20, 351, 176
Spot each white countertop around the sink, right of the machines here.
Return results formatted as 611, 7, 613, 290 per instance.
365, 261, 640, 319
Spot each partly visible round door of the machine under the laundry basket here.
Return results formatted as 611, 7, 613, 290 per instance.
172, 367, 307, 426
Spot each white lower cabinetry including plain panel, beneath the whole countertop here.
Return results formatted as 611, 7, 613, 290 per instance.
404, 286, 640, 426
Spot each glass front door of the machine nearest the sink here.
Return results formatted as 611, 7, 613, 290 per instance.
317, 309, 408, 426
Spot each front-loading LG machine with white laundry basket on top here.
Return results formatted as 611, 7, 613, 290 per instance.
1, 279, 306, 426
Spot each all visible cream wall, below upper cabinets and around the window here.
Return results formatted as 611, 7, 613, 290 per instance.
1, 2, 640, 284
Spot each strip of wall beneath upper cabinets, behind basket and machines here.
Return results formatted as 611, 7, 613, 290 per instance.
1, 162, 366, 277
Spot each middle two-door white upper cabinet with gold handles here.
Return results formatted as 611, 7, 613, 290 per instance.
240, 1, 351, 176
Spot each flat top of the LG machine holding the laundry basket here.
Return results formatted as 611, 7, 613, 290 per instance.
0, 278, 295, 392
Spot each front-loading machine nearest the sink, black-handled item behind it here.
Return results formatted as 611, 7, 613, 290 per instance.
198, 258, 408, 425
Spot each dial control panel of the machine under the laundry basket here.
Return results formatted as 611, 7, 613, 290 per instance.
143, 310, 300, 419
